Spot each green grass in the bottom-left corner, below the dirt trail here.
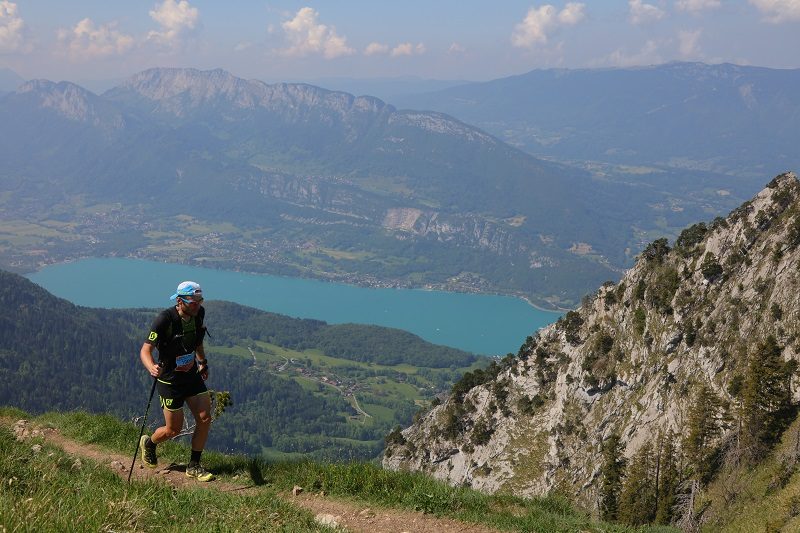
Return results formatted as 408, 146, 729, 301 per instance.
0, 420, 330, 532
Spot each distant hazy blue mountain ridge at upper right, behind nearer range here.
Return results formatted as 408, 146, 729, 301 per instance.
392, 63, 800, 179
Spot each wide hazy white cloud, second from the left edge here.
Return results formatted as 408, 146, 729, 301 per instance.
58, 18, 134, 59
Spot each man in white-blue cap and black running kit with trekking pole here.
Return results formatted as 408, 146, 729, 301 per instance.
139, 281, 214, 481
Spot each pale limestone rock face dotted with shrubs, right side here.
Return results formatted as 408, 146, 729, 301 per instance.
383, 173, 800, 508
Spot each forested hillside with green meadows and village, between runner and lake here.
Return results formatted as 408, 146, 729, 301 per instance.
0, 271, 482, 459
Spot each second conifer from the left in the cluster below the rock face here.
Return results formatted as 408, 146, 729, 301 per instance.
617, 442, 657, 526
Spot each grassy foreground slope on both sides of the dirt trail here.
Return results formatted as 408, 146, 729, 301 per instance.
0, 409, 671, 532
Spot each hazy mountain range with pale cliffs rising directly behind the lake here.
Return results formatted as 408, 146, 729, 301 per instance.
0, 65, 776, 306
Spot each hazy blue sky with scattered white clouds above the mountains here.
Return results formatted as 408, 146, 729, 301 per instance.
0, 0, 800, 82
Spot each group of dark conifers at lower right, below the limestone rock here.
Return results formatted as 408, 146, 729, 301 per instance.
599, 336, 797, 529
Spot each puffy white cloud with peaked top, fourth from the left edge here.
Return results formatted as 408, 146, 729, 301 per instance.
281, 7, 355, 59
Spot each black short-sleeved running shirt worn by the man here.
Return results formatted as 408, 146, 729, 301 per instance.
145, 306, 206, 383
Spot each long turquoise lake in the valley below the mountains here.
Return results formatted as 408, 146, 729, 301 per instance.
28, 258, 560, 355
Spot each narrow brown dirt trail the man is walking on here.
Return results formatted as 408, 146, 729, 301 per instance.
7, 418, 497, 533
